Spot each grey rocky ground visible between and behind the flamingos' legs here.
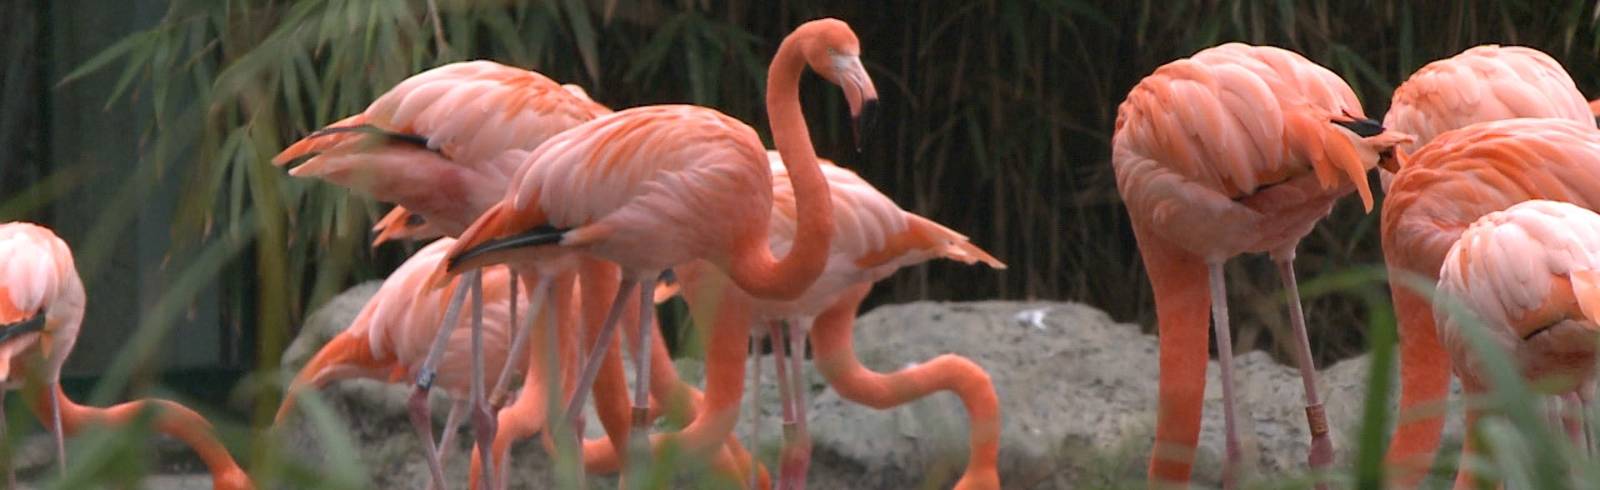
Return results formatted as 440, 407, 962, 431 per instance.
25, 283, 1456, 488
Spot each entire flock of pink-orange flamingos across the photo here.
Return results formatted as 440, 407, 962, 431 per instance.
0, 19, 1600, 488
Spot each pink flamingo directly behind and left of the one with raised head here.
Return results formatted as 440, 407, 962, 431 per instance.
274, 61, 611, 487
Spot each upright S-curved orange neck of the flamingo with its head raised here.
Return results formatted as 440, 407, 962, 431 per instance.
730, 34, 834, 299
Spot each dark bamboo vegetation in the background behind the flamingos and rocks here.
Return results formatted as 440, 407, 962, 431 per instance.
0, 0, 1600, 435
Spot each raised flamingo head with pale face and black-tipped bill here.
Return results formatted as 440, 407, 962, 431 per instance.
794, 19, 878, 151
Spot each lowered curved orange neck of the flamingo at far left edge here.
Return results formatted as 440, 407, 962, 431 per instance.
32, 383, 254, 488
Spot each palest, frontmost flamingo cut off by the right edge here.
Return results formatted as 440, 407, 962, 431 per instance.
1434, 200, 1600, 488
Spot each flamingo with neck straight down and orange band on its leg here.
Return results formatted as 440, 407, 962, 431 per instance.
1112, 43, 1408, 485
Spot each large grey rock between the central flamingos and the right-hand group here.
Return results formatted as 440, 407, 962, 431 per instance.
796, 301, 1459, 488
